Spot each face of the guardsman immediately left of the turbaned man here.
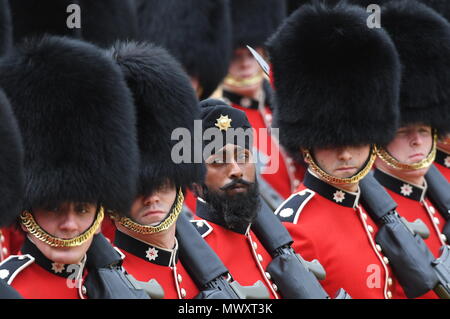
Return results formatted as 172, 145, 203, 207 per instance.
130, 183, 177, 226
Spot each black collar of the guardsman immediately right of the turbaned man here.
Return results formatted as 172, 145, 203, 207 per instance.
303, 170, 360, 208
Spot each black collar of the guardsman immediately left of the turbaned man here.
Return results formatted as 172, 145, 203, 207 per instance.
114, 230, 178, 267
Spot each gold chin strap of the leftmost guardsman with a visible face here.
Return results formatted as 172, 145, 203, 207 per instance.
20, 206, 104, 248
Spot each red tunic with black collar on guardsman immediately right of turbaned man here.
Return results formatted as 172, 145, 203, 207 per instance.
275, 172, 434, 299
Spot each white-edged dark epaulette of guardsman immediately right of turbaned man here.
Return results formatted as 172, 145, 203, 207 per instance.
274, 189, 315, 224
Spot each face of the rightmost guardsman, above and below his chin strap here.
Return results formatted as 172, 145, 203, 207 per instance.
376, 124, 433, 180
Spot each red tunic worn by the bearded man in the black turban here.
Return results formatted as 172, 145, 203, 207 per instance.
193, 200, 279, 299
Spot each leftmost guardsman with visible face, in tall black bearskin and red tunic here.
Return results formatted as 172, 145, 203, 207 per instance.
0, 36, 138, 299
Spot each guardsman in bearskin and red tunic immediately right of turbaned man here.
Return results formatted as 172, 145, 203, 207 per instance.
268, 2, 404, 298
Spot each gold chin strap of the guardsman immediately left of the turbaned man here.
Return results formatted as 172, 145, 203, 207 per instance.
111, 188, 184, 235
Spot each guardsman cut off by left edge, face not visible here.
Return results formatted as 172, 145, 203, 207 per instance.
0, 90, 24, 299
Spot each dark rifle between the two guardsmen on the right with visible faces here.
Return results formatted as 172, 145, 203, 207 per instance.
359, 173, 450, 299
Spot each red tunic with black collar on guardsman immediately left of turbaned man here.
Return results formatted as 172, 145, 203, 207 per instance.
114, 231, 199, 299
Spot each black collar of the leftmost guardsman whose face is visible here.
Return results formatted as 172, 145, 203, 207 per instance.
20, 237, 86, 278
